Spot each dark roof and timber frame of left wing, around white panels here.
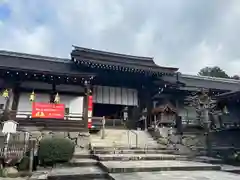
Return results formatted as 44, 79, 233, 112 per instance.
0, 51, 95, 130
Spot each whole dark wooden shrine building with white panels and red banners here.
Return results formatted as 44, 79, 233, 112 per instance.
0, 46, 240, 131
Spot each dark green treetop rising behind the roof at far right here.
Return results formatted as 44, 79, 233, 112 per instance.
198, 66, 230, 78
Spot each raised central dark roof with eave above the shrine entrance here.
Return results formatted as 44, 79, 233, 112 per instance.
71, 46, 178, 76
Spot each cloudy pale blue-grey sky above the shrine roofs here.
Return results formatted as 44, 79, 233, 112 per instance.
0, 0, 240, 75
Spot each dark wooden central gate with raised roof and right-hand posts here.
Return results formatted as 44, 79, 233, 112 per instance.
71, 46, 178, 128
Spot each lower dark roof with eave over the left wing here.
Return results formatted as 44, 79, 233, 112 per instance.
0, 51, 95, 83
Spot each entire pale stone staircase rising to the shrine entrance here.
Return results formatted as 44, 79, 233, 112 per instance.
30, 129, 239, 180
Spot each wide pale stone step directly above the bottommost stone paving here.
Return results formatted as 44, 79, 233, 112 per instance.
100, 160, 221, 173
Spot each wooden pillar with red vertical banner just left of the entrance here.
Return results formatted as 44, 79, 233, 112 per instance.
83, 80, 91, 131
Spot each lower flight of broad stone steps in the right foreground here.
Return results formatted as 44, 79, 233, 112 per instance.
92, 143, 239, 180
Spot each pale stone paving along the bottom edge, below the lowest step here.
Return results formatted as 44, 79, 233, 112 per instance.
110, 171, 240, 180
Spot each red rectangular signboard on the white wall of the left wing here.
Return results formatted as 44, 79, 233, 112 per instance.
32, 102, 65, 119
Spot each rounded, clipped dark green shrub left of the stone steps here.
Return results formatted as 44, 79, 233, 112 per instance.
38, 137, 75, 165
